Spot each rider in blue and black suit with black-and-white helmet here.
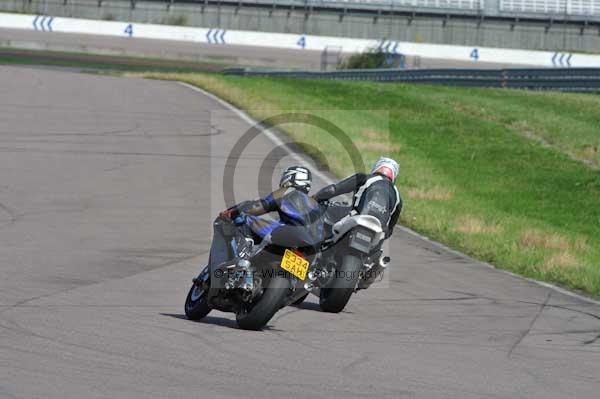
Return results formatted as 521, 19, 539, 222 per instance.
209, 166, 322, 265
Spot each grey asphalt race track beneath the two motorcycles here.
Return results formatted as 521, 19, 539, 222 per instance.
0, 67, 600, 399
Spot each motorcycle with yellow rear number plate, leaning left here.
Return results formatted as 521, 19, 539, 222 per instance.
185, 219, 322, 330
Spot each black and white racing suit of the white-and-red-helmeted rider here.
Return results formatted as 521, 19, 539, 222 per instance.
314, 173, 402, 239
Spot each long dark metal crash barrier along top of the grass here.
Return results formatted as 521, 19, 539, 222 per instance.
224, 68, 600, 91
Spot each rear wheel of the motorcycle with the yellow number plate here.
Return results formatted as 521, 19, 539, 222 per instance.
236, 277, 290, 330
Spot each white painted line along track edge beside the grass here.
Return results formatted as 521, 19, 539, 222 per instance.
177, 82, 600, 305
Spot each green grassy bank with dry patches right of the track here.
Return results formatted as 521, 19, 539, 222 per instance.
136, 74, 600, 296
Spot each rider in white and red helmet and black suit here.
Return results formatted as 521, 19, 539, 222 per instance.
313, 157, 402, 289
